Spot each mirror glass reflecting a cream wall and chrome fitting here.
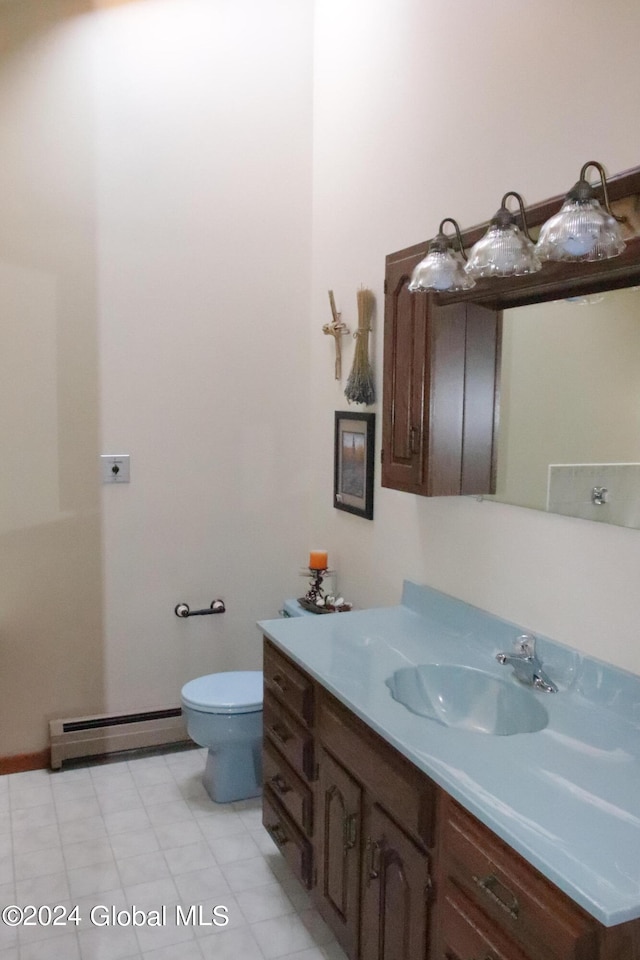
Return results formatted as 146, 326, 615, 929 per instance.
490, 287, 640, 527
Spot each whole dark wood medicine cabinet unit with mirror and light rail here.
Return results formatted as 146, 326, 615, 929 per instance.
381, 161, 640, 527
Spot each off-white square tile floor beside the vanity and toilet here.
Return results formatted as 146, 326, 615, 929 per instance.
0, 750, 344, 960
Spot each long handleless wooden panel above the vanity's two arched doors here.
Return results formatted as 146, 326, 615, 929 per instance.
318, 693, 436, 847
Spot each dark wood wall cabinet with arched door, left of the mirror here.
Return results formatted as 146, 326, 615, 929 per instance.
381, 252, 501, 497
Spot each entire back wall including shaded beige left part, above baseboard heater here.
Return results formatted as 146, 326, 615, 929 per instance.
0, 0, 312, 757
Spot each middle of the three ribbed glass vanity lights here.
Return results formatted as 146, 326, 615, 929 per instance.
465, 190, 542, 278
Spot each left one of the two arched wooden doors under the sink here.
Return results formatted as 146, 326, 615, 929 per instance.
314, 751, 362, 957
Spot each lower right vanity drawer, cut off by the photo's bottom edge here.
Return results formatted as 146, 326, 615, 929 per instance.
435, 885, 538, 960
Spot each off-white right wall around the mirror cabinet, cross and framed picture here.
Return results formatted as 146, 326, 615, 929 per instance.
311, 0, 640, 672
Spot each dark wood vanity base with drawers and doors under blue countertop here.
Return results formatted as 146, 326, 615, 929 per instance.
263, 638, 640, 960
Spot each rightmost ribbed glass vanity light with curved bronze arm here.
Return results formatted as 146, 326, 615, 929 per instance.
536, 160, 626, 261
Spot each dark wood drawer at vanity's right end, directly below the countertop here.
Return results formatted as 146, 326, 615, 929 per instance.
441, 797, 597, 960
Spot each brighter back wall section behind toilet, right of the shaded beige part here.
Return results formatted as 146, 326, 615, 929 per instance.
92, 0, 312, 709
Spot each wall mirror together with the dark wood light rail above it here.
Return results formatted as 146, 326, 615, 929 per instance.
435, 162, 640, 528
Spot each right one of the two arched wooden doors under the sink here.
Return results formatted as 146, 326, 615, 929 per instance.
360, 804, 431, 960
